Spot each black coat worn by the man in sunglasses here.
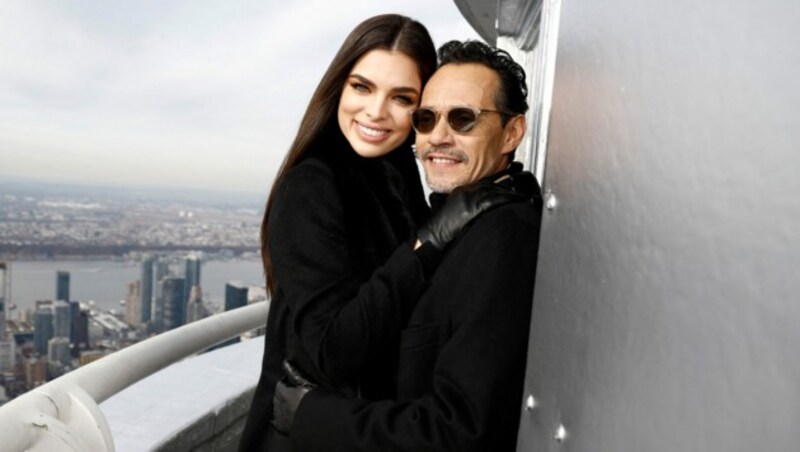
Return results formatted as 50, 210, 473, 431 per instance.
291, 178, 541, 451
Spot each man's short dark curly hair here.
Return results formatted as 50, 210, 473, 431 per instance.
439, 40, 528, 126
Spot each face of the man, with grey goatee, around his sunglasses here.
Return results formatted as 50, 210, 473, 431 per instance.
416, 63, 525, 193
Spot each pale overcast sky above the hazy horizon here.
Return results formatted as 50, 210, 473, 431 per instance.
0, 0, 477, 192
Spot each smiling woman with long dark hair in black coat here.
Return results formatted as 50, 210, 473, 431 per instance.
240, 15, 512, 451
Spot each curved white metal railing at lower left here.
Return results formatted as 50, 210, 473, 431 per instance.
0, 302, 268, 452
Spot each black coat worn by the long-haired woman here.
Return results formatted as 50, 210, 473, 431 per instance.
240, 140, 428, 451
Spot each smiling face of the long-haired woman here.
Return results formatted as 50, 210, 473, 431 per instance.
338, 50, 422, 157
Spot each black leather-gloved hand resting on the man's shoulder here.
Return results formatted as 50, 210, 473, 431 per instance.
417, 173, 531, 250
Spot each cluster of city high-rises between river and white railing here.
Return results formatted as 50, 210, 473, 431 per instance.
0, 253, 266, 405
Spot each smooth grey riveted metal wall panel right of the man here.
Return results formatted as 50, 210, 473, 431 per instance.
519, 0, 800, 452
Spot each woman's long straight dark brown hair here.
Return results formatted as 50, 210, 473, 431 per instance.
261, 14, 436, 295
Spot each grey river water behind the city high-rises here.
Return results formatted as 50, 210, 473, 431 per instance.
4, 259, 264, 310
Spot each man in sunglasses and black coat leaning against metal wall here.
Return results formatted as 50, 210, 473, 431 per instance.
275, 41, 541, 451
